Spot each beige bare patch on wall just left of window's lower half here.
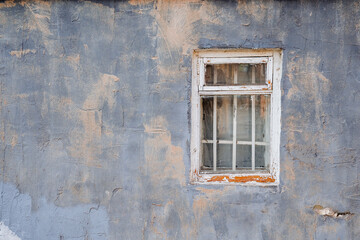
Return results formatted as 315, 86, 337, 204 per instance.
144, 116, 185, 185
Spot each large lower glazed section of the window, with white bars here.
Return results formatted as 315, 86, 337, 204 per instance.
201, 94, 271, 172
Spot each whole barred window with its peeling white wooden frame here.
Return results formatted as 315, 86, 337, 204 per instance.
191, 49, 282, 185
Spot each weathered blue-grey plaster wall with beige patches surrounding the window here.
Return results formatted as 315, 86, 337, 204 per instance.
0, 0, 360, 240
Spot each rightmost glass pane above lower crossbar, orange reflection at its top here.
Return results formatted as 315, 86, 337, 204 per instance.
255, 95, 270, 143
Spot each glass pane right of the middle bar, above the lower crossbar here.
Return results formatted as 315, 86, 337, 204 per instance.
236, 95, 251, 141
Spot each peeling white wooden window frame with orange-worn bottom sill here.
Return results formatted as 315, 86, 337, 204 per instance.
190, 49, 282, 186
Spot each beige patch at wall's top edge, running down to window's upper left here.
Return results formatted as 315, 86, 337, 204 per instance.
150, 0, 221, 102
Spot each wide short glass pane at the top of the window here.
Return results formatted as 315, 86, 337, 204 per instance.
205, 63, 266, 86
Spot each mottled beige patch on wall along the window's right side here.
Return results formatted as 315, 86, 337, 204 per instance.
282, 51, 331, 189
